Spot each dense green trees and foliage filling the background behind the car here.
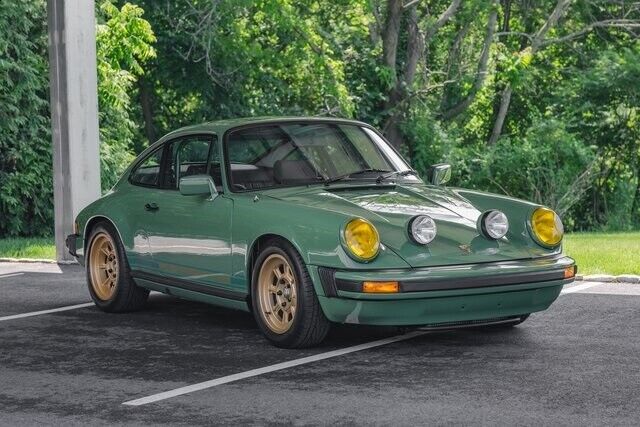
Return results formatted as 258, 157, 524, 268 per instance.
0, 0, 640, 235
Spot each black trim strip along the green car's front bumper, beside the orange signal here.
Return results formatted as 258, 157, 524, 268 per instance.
335, 268, 573, 293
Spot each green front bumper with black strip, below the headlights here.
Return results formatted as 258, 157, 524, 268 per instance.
311, 256, 575, 325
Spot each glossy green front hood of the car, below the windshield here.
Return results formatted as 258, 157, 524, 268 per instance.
268, 184, 548, 267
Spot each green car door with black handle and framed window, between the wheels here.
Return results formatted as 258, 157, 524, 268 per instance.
145, 135, 233, 289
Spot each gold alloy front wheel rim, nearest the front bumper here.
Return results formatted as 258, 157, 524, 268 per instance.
258, 254, 298, 334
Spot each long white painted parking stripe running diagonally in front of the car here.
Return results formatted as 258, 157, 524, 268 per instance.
123, 331, 428, 406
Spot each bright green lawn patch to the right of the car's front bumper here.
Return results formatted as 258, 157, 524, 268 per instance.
564, 232, 640, 275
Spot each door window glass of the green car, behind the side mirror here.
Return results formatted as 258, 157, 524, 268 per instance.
165, 135, 211, 189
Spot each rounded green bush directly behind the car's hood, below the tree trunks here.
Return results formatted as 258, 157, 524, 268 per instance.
450, 119, 596, 228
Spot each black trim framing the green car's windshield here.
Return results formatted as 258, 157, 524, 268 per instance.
222, 118, 418, 193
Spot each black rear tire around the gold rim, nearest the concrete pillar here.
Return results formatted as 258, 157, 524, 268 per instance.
85, 222, 149, 313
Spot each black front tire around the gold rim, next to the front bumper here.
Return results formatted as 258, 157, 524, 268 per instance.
251, 239, 331, 348
